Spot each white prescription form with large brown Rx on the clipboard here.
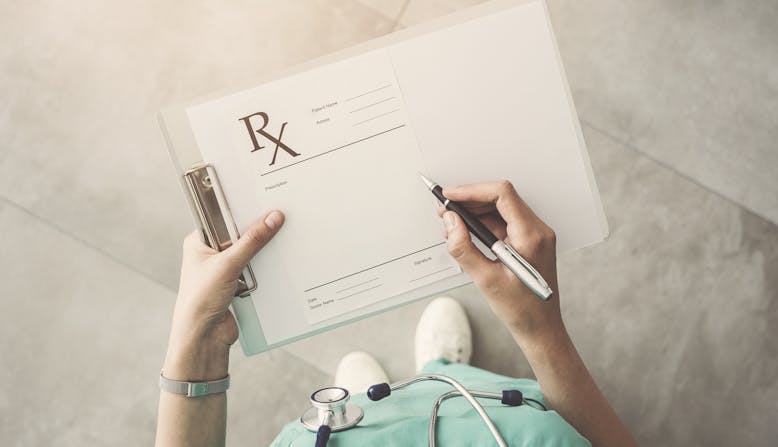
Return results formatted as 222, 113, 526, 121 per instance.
187, 50, 460, 336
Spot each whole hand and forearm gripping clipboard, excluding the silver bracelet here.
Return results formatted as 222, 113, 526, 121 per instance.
156, 211, 284, 447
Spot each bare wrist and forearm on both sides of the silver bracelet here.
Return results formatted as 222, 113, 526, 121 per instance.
156, 336, 229, 447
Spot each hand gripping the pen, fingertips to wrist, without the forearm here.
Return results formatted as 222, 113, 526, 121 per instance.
438, 181, 564, 344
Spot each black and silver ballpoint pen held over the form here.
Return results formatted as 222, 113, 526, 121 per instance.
419, 173, 554, 300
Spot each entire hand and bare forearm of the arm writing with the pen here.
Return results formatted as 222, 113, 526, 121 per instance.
439, 181, 637, 447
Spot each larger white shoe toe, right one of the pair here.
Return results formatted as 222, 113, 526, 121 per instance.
415, 296, 473, 371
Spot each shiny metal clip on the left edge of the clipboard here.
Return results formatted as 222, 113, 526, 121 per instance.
184, 164, 257, 297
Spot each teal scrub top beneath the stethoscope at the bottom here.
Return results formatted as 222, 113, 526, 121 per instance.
271, 360, 591, 447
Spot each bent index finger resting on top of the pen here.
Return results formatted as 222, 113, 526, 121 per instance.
443, 180, 536, 231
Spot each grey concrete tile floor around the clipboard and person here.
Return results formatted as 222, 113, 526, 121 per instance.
0, 0, 778, 446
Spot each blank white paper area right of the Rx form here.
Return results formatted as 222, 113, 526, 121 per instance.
388, 1, 607, 253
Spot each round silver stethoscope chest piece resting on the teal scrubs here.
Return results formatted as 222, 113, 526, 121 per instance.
300, 386, 365, 432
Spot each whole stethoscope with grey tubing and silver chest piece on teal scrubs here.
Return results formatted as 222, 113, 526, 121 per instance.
300, 374, 546, 447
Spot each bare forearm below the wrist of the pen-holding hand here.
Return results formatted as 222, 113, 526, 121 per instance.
514, 326, 637, 447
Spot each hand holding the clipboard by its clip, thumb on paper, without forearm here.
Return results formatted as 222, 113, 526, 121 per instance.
164, 211, 284, 381
